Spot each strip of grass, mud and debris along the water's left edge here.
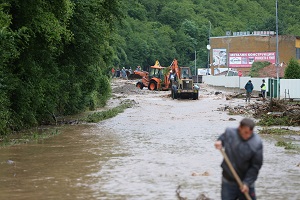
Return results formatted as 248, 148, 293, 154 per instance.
0, 79, 141, 147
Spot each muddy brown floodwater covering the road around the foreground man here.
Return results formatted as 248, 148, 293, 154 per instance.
0, 88, 300, 200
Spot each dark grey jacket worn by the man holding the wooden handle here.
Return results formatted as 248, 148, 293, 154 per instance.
218, 128, 263, 187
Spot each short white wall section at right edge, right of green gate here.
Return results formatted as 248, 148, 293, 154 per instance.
280, 79, 300, 99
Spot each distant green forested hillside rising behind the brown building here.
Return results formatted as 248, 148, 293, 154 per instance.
114, 0, 300, 71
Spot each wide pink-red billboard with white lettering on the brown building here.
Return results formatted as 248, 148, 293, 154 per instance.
229, 52, 276, 68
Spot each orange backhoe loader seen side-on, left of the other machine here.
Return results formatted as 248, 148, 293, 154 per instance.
134, 61, 171, 90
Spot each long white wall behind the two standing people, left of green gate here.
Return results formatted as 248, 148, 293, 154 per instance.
202, 76, 269, 91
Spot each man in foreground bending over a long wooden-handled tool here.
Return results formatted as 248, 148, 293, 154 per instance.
215, 118, 263, 200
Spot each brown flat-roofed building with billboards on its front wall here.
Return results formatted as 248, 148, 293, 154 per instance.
210, 31, 300, 76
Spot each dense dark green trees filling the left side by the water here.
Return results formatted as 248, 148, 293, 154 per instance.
0, 0, 123, 135
